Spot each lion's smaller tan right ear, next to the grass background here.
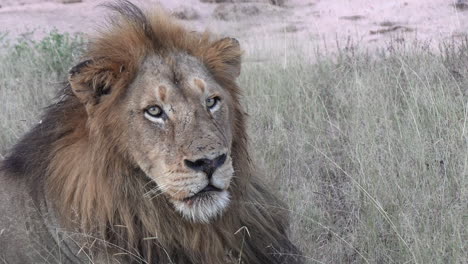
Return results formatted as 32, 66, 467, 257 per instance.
204, 38, 242, 79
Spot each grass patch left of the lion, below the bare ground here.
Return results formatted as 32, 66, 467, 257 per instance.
0, 31, 84, 154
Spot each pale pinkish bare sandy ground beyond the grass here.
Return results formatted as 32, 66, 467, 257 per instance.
0, 0, 468, 51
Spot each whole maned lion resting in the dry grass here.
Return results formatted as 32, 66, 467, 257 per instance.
0, 1, 303, 264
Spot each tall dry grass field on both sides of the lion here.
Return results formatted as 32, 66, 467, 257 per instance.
0, 29, 468, 263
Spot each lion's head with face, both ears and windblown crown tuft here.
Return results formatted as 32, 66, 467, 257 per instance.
65, 5, 241, 223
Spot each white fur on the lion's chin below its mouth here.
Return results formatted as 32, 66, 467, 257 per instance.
173, 191, 230, 224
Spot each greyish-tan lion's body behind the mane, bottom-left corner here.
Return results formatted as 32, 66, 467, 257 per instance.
0, 171, 67, 264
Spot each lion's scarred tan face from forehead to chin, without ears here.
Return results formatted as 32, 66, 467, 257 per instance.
123, 53, 234, 222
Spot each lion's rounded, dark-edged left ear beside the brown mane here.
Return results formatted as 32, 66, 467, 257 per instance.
68, 60, 119, 105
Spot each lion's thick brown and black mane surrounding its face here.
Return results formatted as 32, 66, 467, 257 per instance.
3, 1, 302, 264
